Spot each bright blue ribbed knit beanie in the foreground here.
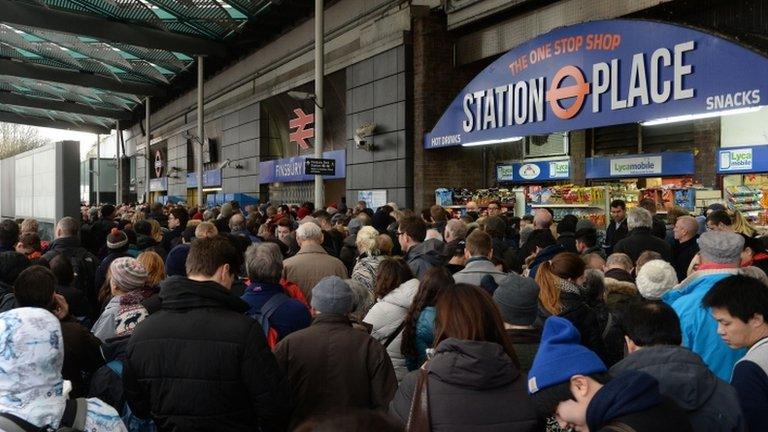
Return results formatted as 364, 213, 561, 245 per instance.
528, 316, 608, 394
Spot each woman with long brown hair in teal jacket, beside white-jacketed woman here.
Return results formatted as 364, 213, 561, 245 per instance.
400, 267, 454, 371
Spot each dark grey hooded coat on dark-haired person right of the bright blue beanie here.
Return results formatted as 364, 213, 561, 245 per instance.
610, 345, 745, 432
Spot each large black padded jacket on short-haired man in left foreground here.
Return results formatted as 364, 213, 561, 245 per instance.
123, 276, 290, 432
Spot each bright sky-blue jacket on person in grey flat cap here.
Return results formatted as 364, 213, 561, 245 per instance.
662, 272, 746, 382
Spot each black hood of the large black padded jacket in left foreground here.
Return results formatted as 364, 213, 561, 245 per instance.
160, 276, 249, 313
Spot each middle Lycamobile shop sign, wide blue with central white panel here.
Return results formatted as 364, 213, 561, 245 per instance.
585, 152, 694, 179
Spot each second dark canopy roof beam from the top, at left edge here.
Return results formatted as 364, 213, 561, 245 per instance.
0, 58, 165, 96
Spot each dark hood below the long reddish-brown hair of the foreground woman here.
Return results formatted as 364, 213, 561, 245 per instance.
428, 338, 520, 390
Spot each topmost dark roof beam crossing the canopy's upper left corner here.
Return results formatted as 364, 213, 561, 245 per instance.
0, 0, 226, 56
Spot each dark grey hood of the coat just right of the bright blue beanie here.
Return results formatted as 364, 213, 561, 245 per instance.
611, 346, 717, 411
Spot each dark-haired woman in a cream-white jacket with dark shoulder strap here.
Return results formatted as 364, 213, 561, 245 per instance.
363, 258, 419, 381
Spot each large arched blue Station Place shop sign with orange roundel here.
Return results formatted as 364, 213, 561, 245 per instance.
424, 20, 768, 149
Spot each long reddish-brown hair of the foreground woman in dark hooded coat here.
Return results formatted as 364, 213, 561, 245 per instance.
434, 283, 520, 368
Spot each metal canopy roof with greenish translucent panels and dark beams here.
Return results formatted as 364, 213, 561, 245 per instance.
0, 0, 283, 133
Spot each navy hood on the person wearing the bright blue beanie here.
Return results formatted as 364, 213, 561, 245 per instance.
587, 371, 662, 431
